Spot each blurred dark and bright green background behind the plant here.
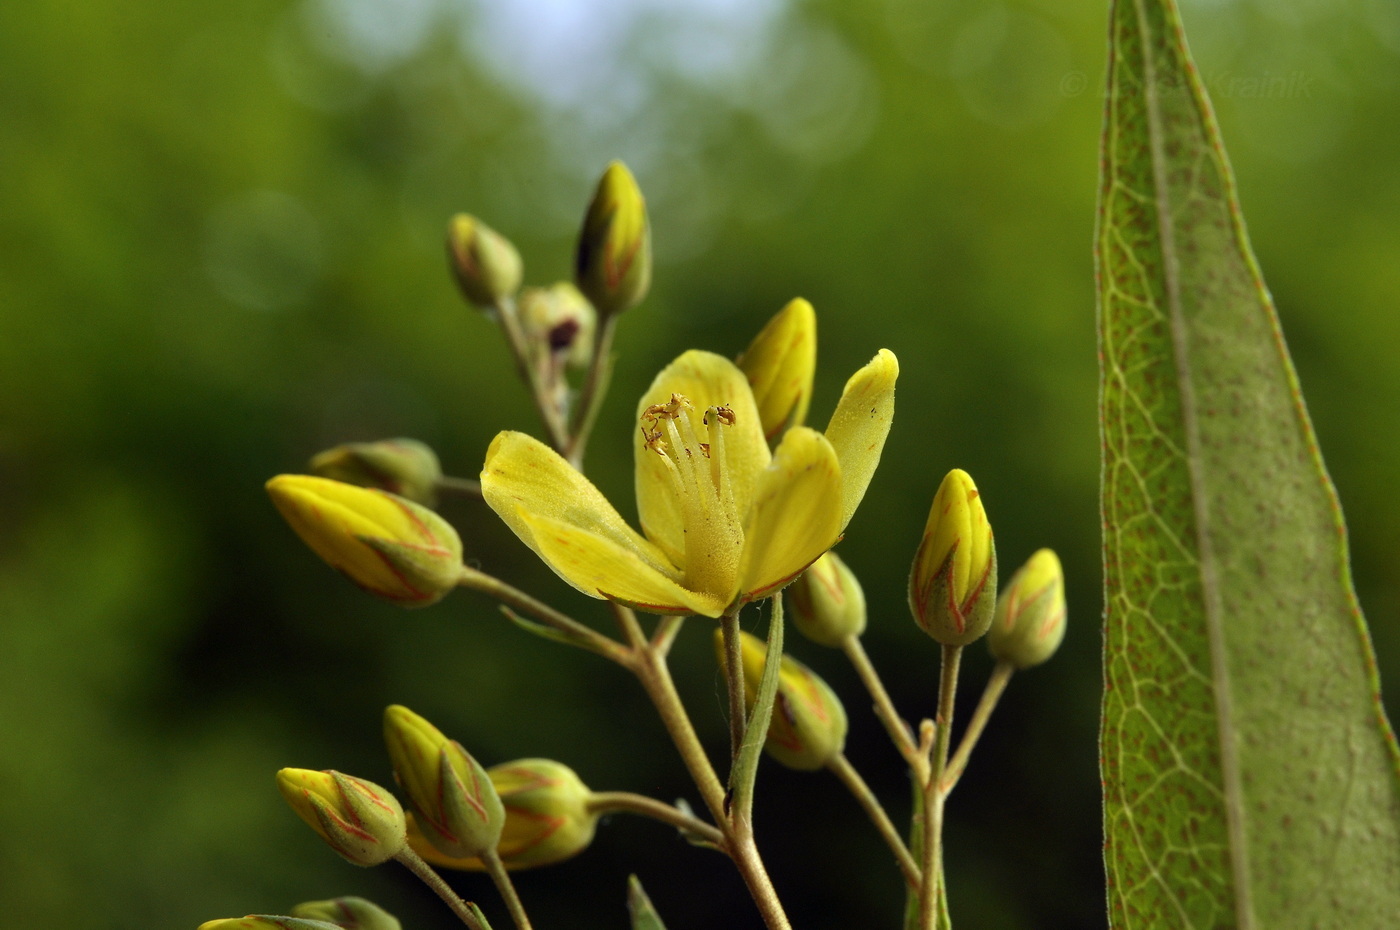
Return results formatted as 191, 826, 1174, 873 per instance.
0, 0, 1400, 930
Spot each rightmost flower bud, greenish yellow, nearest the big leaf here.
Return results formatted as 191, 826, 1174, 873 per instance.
987, 549, 1065, 668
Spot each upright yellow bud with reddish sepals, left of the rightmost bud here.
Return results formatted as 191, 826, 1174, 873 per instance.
909, 468, 997, 646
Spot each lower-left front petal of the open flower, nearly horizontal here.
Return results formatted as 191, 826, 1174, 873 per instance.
521, 513, 728, 616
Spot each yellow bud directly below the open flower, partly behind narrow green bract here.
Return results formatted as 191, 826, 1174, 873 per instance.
714, 629, 846, 772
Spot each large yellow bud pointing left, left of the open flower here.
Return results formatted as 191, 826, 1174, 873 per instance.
267, 475, 462, 606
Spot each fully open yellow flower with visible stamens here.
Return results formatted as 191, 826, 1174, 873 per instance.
482, 349, 899, 616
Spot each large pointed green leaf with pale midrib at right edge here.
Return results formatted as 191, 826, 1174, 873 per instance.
1096, 0, 1400, 930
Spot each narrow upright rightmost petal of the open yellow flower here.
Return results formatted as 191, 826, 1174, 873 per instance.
826, 349, 899, 529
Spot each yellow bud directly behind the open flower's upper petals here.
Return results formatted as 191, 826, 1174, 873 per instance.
738, 297, 816, 443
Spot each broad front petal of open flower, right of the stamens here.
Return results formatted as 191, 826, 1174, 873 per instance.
739, 426, 841, 599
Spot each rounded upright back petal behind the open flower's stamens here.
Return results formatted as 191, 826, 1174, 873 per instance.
631, 350, 771, 564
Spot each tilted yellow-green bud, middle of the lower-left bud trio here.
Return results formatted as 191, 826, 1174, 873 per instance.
384, 705, 505, 859
